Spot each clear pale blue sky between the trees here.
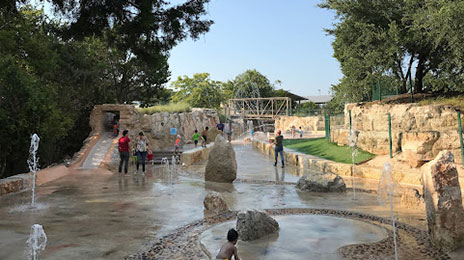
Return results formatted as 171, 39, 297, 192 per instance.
169, 0, 342, 96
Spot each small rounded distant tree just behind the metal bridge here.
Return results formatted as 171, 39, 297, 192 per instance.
224, 69, 274, 99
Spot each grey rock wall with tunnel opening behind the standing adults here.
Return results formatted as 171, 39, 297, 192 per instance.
90, 104, 219, 150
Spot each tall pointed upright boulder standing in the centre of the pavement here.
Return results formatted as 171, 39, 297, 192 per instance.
205, 135, 237, 183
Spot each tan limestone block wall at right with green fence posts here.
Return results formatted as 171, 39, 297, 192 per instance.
331, 103, 461, 167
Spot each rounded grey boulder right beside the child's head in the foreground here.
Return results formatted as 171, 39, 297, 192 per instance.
236, 210, 279, 241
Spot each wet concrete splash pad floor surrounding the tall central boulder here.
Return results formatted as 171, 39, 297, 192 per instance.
0, 143, 425, 259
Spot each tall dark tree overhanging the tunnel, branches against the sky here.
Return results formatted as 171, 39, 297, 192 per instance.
0, 0, 213, 106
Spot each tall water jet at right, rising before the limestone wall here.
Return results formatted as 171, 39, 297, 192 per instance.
377, 162, 398, 260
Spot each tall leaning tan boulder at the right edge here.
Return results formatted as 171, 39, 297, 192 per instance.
422, 150, 464, 250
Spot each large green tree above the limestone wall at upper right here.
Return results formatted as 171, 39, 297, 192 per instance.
320, 0, 456, 101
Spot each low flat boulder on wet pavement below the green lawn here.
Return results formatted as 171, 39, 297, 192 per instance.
296, 173, 346, 192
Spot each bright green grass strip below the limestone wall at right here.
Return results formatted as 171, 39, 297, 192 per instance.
284, 138, 375, 163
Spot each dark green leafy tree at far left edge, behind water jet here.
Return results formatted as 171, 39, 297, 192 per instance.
0, 9, 73, 177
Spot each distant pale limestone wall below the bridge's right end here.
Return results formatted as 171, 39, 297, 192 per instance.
274, 116, 324, 133
